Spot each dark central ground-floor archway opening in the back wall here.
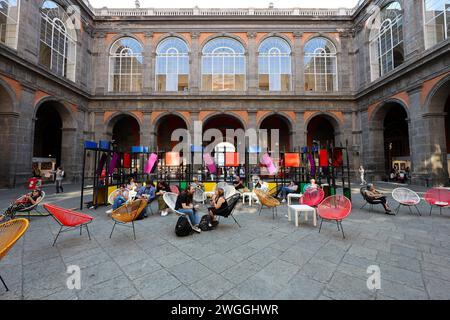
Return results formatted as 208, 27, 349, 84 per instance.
203, 114, 245, 147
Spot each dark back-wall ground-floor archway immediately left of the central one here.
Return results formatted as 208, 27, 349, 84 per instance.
156, 114, 187, 151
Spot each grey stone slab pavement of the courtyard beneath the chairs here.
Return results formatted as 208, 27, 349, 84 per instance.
0, 184, 450, 300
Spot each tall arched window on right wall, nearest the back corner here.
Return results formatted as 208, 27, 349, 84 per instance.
370, 2, 404, 81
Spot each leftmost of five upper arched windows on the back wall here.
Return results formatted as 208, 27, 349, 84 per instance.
109, 37, 143, 92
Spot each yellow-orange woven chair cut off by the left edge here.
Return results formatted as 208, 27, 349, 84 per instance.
0, 219, 29, 291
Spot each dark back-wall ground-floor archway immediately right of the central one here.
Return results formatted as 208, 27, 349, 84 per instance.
260, 115, 292, 152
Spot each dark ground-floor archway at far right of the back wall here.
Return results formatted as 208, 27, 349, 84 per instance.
307, 115, 337, 148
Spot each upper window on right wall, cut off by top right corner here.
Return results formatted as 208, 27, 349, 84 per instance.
424, 0, 450, 49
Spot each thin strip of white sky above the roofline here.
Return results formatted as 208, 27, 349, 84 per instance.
89, 0, 358, 8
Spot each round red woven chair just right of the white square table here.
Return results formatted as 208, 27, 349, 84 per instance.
317, 195, 352, 239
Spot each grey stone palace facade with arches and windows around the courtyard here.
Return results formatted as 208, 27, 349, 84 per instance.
0, 0, 450, 187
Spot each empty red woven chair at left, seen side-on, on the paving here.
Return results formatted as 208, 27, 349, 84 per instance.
44, 204, 94, 246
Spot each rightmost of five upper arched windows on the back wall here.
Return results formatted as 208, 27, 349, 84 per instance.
304, 37, 338, 92
